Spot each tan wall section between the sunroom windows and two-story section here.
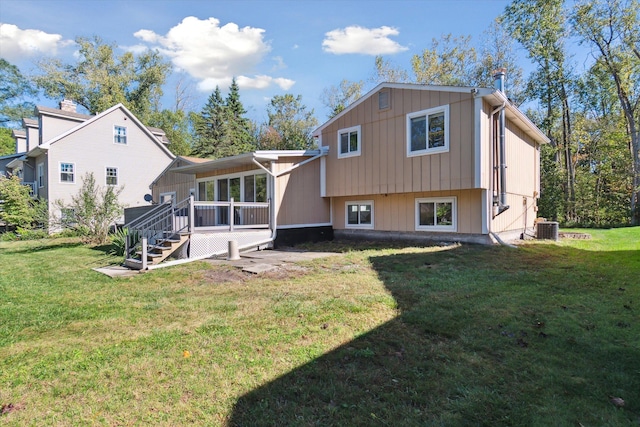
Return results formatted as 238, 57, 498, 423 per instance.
273, 157, 331, 227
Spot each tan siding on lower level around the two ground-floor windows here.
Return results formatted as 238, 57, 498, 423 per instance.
333, 190, 482, 234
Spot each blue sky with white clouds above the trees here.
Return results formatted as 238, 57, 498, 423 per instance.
0, 0, 528, 123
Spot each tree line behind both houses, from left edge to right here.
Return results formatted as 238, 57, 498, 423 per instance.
0, 0, 640, 226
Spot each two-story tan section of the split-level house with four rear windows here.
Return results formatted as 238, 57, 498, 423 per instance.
314, 84, 548, 243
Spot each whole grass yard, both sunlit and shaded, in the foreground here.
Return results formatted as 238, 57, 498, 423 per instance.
0, 227, 640, 426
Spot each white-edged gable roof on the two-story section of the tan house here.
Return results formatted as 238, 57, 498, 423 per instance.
312, 83, 549, 143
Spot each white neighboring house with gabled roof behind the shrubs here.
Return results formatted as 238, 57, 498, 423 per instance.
7, 100, 175, 227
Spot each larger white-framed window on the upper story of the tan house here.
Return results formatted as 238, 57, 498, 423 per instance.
407, 105, 449, 157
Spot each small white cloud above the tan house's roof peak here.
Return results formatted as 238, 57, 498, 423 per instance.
322, 25, 408, 55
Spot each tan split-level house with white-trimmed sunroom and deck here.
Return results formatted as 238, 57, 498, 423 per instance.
126, 72, 549, 270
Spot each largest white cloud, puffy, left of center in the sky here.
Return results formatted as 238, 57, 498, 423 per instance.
134, 16, 293, 91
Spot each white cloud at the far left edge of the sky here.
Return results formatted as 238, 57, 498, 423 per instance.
0, 23, 75, 62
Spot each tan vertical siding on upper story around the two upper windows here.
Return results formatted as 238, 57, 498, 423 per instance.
322, 88, 475, 197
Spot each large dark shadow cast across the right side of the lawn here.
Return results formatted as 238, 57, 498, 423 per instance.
229, 245, 640, 426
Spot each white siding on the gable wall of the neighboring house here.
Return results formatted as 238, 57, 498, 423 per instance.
47, 108, 173, 214
